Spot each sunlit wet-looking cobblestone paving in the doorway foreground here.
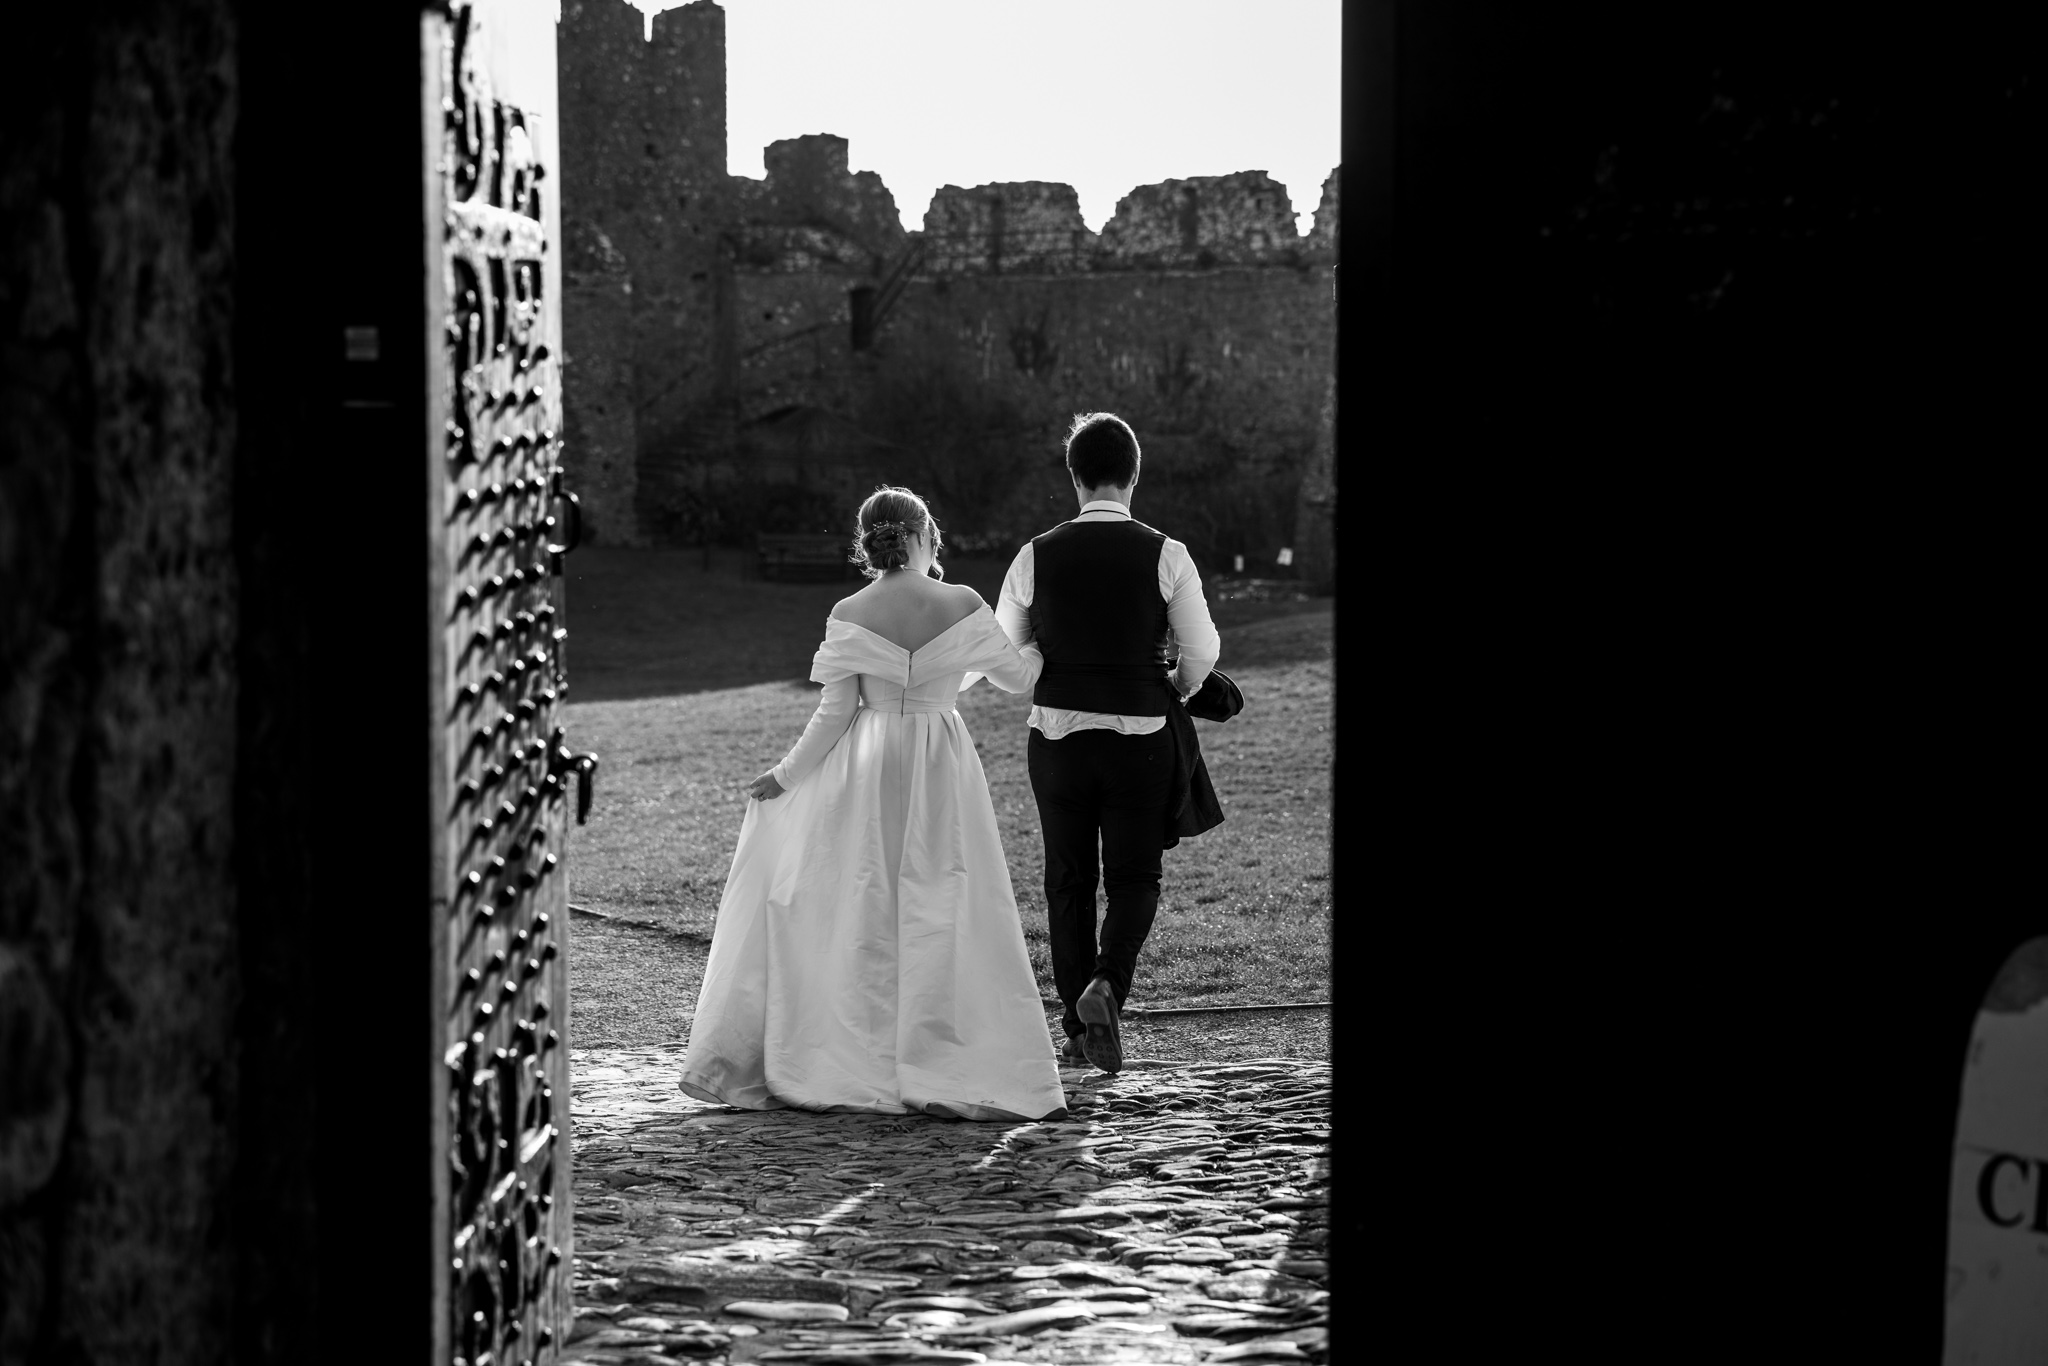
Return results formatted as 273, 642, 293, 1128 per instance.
563, 1049, 1329, 1366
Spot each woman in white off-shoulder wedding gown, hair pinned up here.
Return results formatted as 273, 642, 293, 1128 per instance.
682, 487, 1065, 1120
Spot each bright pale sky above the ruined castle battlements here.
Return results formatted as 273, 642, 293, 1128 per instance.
643, 0, 1341, 231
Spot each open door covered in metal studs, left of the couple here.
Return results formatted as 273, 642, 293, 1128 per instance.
422, 0, 577, 1366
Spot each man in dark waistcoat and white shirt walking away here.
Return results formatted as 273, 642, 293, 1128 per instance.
995, 412, 1219, 1071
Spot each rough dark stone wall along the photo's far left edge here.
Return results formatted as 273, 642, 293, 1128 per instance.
0, 0, 238, 1362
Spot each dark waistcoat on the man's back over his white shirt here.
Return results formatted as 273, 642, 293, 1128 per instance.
1030, 518, 1169, 717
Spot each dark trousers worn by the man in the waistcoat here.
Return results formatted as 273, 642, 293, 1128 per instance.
1028, 729, 1174, 1036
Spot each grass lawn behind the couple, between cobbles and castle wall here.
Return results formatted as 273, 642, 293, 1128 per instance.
567, 547, 1331, 1057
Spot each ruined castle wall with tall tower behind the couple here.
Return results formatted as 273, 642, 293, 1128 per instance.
561, 0, 1337, 565
